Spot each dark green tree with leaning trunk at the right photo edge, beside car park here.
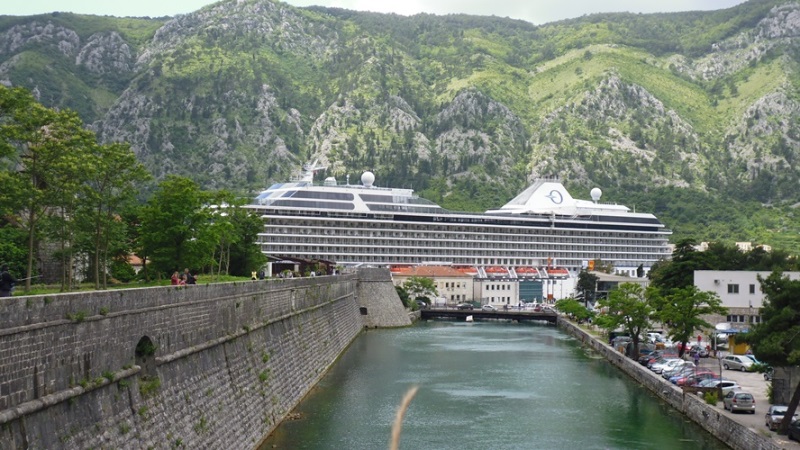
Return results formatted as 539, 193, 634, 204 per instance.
742, 271, 800, 434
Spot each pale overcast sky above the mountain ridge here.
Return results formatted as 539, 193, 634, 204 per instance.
0, 0, 744, 25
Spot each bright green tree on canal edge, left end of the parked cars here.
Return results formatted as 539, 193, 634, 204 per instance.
594, 283, 655, 357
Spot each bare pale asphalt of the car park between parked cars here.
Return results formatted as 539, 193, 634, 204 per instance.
700, 358, 800, 449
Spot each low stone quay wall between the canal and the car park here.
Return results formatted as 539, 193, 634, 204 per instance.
558, 317, 781, 450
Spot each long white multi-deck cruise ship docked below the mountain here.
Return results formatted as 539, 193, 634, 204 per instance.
247, 163, 671, 276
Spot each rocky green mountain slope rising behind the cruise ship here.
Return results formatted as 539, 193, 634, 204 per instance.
0, 0, 800, 251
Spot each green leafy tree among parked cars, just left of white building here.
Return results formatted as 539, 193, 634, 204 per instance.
652, 285, 728, 357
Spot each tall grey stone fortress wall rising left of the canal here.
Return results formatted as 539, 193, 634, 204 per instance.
0, 273, 408, 449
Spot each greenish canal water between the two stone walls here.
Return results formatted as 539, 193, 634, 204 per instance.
261, 321, 728, 450
